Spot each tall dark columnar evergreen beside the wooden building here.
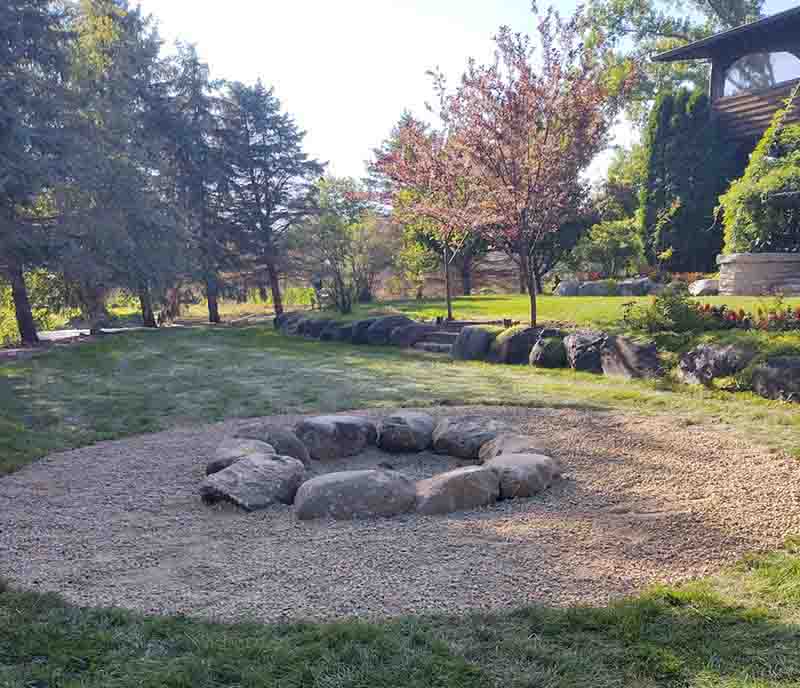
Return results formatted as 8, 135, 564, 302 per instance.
639, 88, 741, 272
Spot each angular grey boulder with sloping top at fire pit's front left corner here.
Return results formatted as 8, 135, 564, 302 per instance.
200, 454, 304, 511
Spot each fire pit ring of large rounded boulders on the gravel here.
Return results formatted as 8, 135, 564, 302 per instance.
200, 411, 562, 520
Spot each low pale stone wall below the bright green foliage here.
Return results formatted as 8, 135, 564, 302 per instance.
717, 253, 800, 296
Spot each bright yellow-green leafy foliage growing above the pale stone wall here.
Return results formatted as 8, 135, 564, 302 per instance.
720, 91, 800, 253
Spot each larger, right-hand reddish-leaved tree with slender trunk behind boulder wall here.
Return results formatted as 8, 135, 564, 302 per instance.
443, 10, 630, 324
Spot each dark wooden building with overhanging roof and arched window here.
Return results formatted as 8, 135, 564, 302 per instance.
653, 7, 800, 147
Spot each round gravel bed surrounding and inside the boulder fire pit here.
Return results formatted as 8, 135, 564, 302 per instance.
0, 407, 800, 621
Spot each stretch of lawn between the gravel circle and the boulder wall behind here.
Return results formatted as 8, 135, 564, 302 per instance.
0, 326, 800, 474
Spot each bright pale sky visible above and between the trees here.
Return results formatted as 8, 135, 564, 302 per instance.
138, 0, 797, 176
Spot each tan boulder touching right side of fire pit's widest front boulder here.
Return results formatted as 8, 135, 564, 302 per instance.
417, 466, 500, 515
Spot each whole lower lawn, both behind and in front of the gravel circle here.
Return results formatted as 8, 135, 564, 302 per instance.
0, 326, 800, 688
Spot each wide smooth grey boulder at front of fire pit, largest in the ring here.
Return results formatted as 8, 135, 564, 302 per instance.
294, 470, 416, 520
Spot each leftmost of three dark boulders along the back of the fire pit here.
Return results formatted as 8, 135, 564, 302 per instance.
294, 416, 378, 461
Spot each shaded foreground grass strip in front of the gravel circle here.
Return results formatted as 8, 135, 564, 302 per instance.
0, 543, 800, 688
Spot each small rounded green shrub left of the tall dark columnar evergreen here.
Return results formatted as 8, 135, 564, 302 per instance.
573, 219, 646, 277
